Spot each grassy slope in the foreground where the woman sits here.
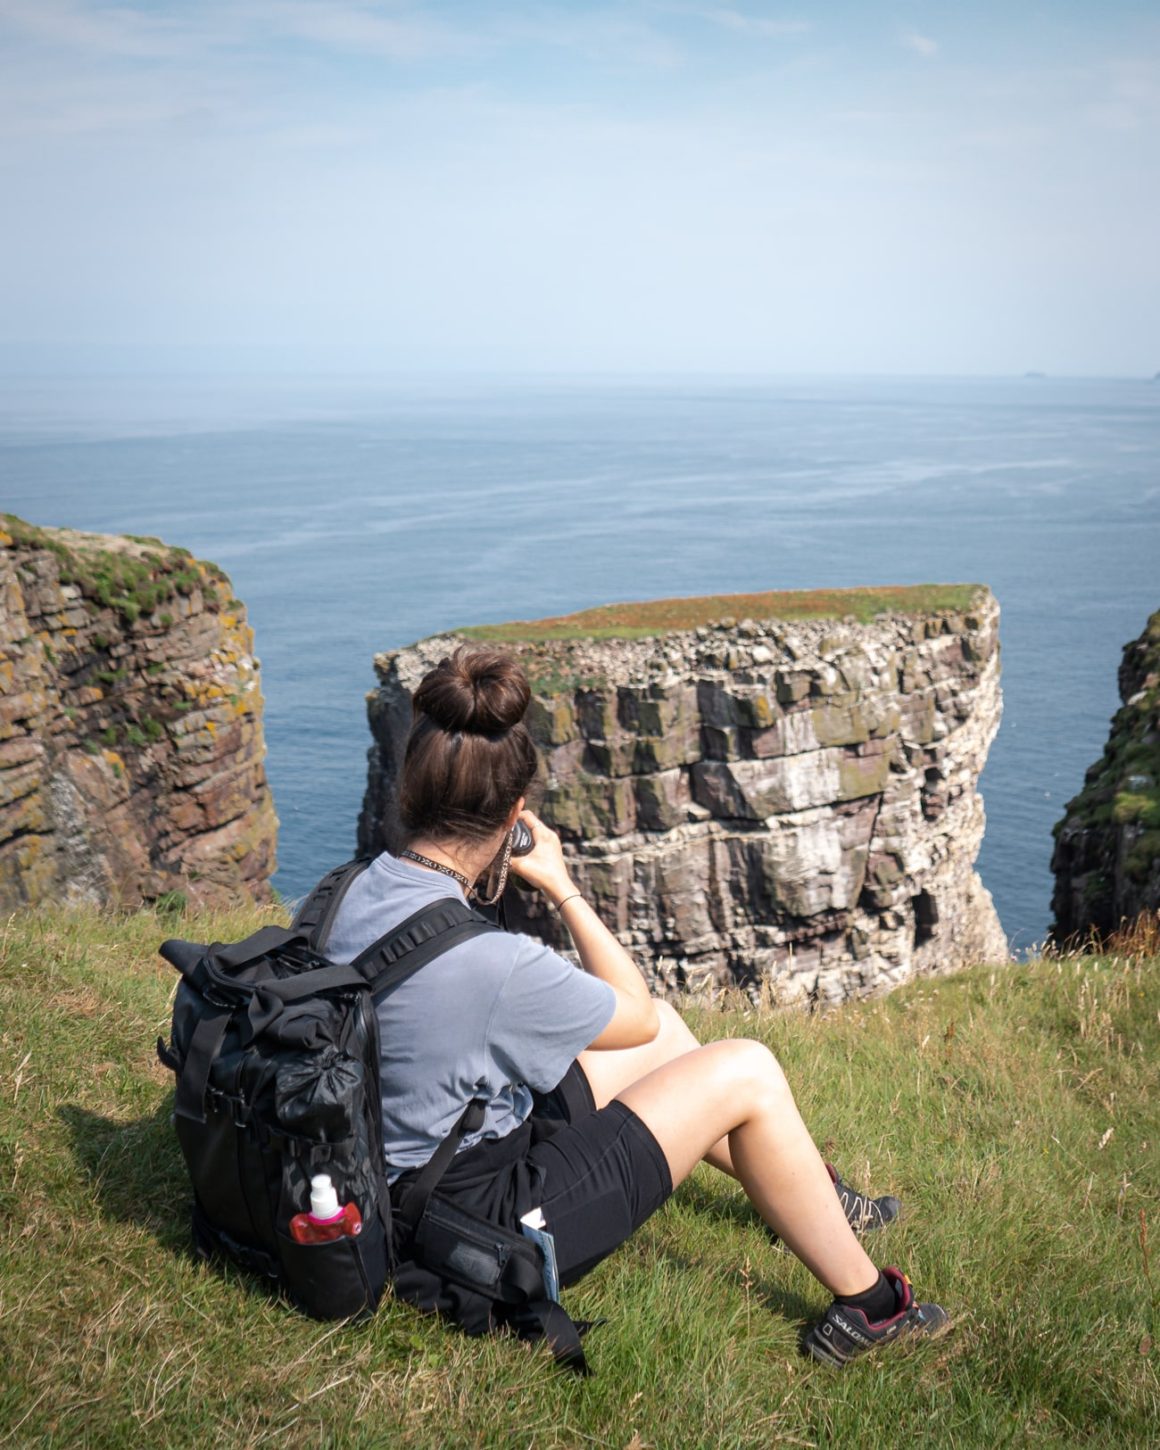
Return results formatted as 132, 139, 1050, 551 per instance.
0, 912, 1160, 1450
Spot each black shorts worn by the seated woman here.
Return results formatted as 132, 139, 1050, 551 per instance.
417, 1063, 673, 1285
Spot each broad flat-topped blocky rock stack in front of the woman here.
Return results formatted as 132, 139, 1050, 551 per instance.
360, 586, 1008, 1002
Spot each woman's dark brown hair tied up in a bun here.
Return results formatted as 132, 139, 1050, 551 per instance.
399, 645, 537, 841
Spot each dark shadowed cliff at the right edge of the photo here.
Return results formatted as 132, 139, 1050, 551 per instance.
1051, 612, 1160, 941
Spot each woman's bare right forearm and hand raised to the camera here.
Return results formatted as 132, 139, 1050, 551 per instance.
512, 811, 660, 1051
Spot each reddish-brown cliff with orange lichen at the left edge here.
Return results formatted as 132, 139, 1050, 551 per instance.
0, 515, 277, 911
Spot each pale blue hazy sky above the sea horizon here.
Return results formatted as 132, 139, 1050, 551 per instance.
0, 0, 1160, 377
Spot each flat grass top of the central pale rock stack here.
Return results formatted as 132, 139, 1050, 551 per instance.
455, 584, 982, 644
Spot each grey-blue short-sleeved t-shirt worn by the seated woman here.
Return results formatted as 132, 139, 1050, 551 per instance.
326, 853, 616, 1177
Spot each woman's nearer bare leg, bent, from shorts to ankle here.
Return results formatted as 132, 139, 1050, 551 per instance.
616, 1040, 879, 1295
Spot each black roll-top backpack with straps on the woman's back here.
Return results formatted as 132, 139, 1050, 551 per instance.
157, 860, 587, 1373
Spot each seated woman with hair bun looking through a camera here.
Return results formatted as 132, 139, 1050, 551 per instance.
328, 650, 948, 1364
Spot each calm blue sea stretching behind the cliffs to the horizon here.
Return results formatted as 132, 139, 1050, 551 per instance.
0, 378, 1160, 948
